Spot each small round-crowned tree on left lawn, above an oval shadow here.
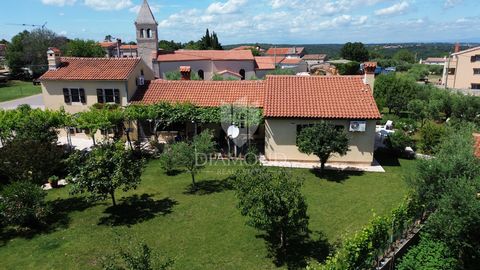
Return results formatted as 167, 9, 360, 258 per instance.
69, 142, 145, 206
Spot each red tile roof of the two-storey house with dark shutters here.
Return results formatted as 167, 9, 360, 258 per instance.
40, 57, 141, 81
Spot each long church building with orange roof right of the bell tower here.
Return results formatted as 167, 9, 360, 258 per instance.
153, 50, 255, 80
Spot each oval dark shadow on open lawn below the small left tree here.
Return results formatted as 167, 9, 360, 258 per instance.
98, 194, 178, 226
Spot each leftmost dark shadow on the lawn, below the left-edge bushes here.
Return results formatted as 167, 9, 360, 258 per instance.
0, 197, 93, 246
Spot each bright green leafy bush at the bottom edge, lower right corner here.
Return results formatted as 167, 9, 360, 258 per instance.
397, 238, 457, 270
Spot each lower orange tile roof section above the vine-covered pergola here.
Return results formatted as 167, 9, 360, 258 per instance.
132, 80, 265, 107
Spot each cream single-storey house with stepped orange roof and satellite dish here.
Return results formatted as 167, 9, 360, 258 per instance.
133, 67, 381, 164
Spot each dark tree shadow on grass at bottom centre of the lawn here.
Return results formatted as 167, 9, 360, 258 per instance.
257, 232, 332, 269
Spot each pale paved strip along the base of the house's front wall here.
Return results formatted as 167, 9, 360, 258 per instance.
260, 156, 385, 172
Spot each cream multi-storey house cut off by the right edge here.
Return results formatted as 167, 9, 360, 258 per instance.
442, 45, 480, 94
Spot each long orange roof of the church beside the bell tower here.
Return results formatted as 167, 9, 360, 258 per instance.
157, 50, 254, 62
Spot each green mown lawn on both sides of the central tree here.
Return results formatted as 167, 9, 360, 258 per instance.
0, 155, 414, 269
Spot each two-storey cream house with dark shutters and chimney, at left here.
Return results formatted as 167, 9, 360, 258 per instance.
40, 48, 154, 113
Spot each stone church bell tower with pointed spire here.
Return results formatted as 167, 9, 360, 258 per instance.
135, 0, 158, 69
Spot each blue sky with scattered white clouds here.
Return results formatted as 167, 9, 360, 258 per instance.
0, 0, 480, 44
